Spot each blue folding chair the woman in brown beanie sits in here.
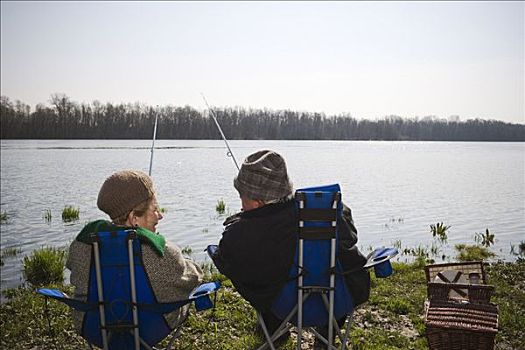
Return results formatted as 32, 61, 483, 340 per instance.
37, 230, 220, 350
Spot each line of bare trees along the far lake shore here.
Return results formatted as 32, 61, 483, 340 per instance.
0, 94, 525, 141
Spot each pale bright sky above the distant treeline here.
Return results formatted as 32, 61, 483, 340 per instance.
0, 1, 525, 124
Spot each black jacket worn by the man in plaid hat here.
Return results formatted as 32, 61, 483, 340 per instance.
212, 199, 370, 312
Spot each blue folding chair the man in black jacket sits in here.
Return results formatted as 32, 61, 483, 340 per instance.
257, 184, 397, 350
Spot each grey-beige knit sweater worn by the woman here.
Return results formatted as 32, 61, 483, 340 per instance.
66, 232, 202, 332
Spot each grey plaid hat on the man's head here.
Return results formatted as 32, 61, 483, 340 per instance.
233, 150, 292, 201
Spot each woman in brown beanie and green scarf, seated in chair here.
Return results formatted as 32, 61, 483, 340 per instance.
66, 170, 202, 331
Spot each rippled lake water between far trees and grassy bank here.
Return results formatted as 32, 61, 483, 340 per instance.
0, 140, 525, 289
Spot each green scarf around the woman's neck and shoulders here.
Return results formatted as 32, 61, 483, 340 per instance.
76, 220, 166, 256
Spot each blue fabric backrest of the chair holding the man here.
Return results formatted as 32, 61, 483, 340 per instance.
272, 184, 354, 327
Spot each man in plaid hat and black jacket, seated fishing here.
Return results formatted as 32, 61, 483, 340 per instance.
212, 150, 370, 348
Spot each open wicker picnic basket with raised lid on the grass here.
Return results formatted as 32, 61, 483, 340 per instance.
425, 262, 498, 350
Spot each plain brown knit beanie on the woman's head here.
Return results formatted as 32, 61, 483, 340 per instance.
97, 170, 155, 219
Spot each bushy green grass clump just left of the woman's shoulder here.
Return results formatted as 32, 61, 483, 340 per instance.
23, 247, 66, 287
